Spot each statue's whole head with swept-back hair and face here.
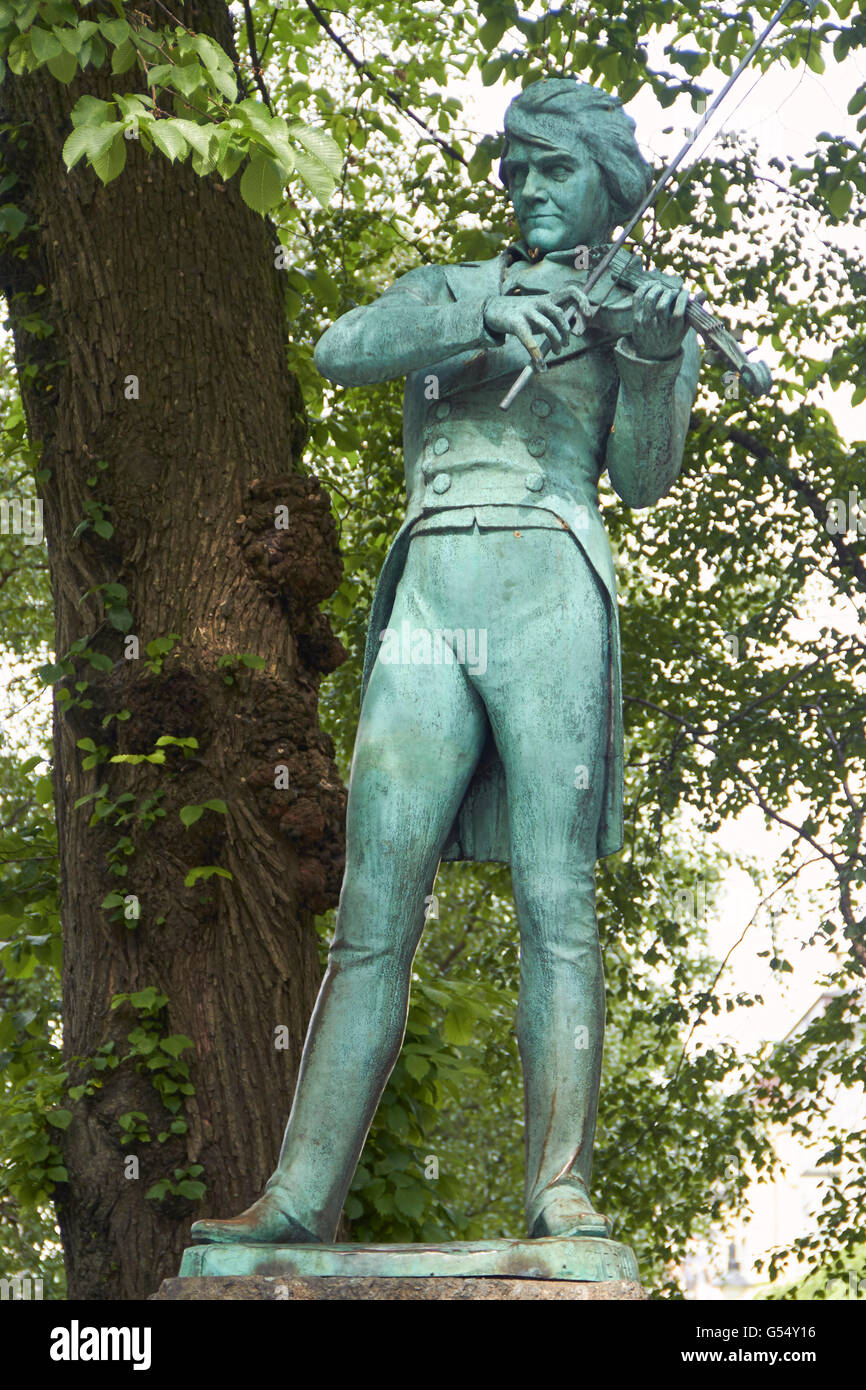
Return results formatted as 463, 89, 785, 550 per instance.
499, 78, 649, 252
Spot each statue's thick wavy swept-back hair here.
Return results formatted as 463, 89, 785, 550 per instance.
499, 78, 651, 224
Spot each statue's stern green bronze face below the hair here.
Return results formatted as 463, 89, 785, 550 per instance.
503, 140, 613, 252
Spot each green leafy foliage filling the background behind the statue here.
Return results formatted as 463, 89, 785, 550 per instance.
0, 0, 866, 1294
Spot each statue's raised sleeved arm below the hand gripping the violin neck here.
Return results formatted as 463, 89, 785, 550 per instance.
605, 329, 701, 507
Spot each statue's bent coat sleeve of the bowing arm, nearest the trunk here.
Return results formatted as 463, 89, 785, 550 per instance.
314, 265, 502, 386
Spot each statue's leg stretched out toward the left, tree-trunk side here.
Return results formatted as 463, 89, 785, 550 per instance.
193, 537, 488, 1243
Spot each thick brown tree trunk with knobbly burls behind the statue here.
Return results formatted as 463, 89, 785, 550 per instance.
0, 0, 345, 1298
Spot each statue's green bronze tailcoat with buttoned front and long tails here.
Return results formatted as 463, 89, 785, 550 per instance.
316, 243, 699, 863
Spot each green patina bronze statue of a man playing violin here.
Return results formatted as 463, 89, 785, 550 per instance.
193, 79, 699, 1244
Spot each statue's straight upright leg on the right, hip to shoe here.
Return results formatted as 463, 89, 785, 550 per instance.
481, 531, 610, 1236
